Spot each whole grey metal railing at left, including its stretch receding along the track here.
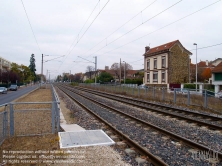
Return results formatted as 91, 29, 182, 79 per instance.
0, 86, 60, 145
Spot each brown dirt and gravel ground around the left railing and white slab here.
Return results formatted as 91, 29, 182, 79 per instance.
0, 86, 127, 166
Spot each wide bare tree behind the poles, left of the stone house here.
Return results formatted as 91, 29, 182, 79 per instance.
110, 63, 133, 79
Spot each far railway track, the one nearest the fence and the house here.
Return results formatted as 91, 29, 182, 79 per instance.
75, 85, 222, 130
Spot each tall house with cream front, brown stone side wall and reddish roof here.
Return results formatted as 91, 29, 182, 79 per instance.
143, 40, 192, 86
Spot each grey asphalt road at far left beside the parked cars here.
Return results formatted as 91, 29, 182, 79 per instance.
0, 85, 39, 105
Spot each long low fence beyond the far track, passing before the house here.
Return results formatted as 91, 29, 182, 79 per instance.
80, 84, 222, 112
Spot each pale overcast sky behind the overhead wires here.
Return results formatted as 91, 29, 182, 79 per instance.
0, 0, 222, 78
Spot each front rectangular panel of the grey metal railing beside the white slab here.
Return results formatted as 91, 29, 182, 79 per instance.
9, 102, 58, 136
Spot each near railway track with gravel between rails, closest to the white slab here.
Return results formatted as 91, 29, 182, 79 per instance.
56, 86, 222, 165
